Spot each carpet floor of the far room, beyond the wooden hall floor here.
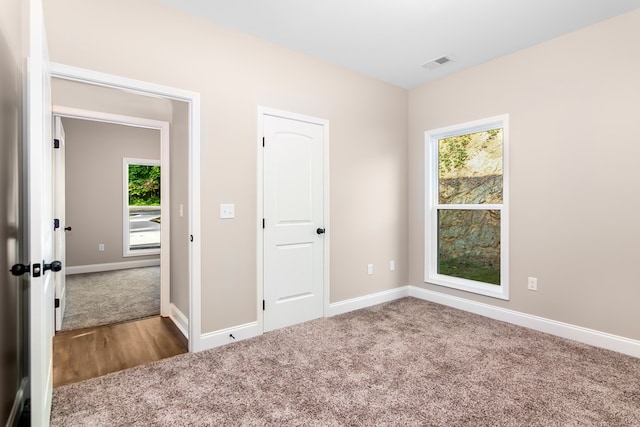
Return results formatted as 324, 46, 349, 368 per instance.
62, 267, 160, 331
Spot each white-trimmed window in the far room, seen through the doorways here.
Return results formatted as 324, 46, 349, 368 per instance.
123, 158, 161, 256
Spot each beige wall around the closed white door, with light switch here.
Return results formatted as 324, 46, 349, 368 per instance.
44, 0, 408, 333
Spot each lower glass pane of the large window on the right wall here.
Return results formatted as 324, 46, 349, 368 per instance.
438, 209, 500, 285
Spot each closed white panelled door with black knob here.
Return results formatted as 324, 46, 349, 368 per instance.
263, 114, 325, 331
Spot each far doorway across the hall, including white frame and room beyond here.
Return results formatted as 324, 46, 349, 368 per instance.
53, 106, 171, 335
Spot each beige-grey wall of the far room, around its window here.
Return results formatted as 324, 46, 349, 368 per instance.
62, 118, 160, 267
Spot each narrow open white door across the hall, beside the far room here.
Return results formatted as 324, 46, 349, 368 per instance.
53, 116, 67, 331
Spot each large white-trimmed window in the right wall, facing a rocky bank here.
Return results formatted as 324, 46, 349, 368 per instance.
425, 115, 509, 299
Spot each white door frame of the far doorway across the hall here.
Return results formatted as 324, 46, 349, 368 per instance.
51, 105, 171, 317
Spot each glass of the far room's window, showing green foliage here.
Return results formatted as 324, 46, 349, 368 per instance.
129, 164, 161, 251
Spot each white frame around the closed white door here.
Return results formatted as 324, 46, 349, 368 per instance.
256, 106, 331, 333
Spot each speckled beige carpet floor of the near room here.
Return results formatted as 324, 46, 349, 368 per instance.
52, 298, 640, 426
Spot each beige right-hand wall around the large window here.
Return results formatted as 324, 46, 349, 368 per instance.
409, 11, 640, 339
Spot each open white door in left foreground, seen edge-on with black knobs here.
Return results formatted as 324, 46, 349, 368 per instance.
25, 0, 58, 426
